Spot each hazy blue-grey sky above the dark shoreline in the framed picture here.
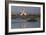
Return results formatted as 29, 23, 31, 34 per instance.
11, 6, 40, 14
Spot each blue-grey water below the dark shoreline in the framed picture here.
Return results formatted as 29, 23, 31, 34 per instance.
11, 18, 40, 29
